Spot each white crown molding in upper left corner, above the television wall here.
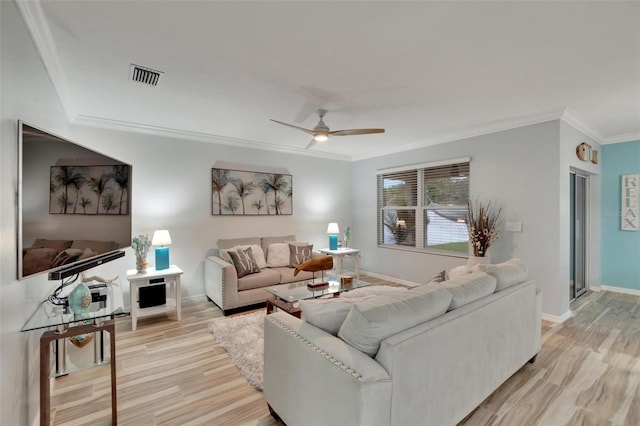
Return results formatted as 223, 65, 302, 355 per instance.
16, 0, 76, 121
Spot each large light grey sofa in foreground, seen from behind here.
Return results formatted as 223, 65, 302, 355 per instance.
263, 260, 541, 426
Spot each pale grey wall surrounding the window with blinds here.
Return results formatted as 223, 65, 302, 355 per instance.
352, 121, 575, 316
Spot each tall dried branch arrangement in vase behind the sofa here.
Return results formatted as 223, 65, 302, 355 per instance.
467, 200, 502, 257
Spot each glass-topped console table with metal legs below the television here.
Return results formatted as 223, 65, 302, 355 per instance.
22, 285, 126, 426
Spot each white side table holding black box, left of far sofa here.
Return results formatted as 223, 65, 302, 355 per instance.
127, 265, 182, 330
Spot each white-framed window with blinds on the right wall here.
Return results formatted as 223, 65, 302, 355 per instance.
377, 158, 470, 254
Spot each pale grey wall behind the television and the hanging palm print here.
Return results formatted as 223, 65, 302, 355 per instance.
0, 1, 351, 425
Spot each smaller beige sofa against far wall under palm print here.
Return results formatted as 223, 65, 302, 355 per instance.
204, 235, 322, 315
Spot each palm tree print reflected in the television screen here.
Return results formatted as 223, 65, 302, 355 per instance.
49, 165, 131, 215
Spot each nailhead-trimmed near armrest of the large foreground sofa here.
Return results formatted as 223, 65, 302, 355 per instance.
263, 312, 392, 425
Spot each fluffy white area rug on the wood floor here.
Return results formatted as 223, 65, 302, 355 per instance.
209, 310, 266, 390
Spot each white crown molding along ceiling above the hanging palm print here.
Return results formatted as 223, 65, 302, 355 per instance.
72, 115, 351, 161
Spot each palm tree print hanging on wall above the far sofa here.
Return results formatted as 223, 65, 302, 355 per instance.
211, 168, 293, 216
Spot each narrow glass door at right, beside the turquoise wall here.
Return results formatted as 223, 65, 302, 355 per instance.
569, 172, 587, 300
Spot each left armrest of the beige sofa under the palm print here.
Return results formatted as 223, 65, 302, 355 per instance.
204, 256, 238, 311
